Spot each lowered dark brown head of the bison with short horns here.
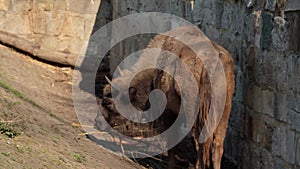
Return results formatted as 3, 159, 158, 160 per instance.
95, 69, 155, 130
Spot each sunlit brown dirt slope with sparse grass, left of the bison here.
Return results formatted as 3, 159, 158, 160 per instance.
0, 45, 142, 169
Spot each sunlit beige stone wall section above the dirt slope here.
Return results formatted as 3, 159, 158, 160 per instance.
0, 0, 100, 65
